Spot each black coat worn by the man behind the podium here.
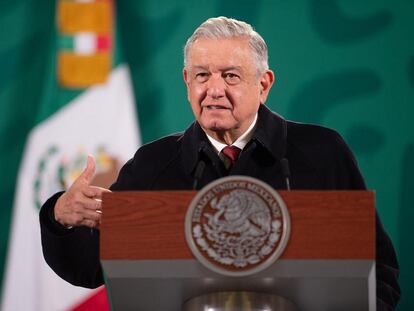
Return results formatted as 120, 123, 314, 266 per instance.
40, 105, 400, 309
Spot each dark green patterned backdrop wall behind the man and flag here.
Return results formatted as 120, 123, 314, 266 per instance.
0, 0, 414, 310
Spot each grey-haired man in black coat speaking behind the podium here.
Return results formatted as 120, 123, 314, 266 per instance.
40, 17, 399, 309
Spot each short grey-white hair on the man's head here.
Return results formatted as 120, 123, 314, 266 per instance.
184, 16, 269, 75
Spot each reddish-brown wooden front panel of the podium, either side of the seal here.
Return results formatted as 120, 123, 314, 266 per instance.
101, 191, 375, 260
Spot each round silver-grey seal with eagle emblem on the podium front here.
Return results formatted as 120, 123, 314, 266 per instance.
185, 176, 290, 276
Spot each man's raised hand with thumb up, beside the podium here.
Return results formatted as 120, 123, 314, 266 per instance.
54, 156, 110, 228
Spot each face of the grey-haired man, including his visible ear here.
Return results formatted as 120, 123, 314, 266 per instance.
183, 38, 273, 144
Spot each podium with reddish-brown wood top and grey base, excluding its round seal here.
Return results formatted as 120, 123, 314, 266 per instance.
100, 191, 376, 311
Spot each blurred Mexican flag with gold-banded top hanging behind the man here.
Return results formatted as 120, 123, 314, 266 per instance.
1, 0, 140, 311
